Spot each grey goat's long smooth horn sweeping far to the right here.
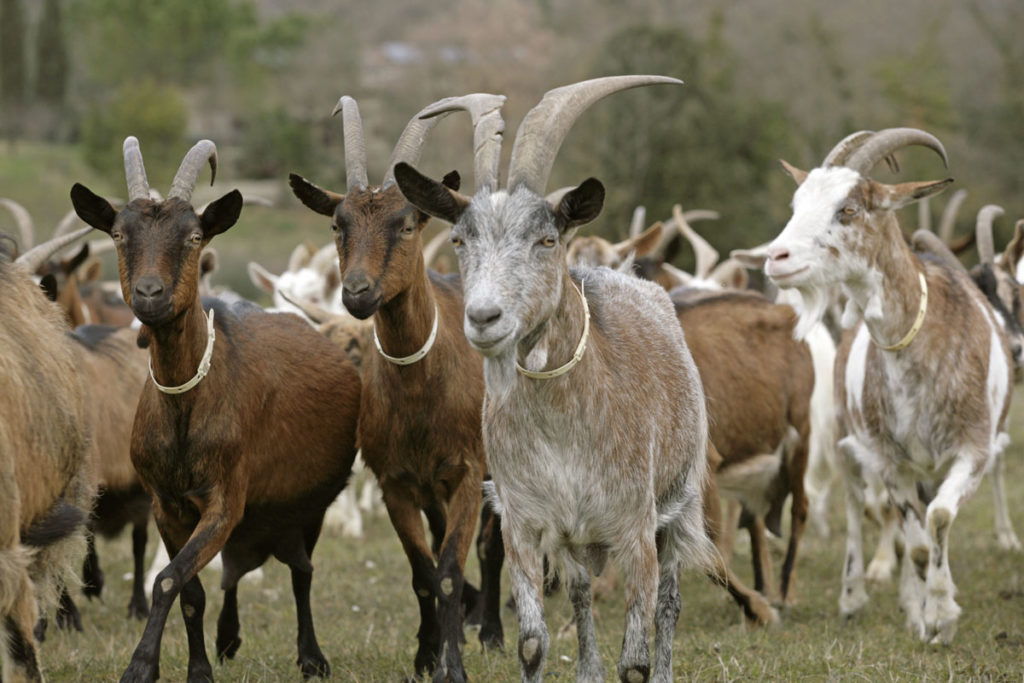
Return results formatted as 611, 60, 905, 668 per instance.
508, 76, 683, 196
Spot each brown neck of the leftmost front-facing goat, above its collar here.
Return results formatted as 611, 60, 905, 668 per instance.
139, 297, 222, 389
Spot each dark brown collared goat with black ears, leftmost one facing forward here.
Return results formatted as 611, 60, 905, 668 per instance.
71, 137, 360, 681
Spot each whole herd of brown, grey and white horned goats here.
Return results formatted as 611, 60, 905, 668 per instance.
0, 76, 1024, 683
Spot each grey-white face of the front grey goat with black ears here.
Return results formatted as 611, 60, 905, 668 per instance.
452, 188, 573, 357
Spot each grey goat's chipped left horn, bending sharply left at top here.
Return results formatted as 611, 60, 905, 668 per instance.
411, 92, 506, 191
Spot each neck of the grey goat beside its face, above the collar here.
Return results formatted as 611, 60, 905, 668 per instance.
516, 268, 588, 382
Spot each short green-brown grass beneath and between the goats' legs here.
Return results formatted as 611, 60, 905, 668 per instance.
36, 391, 1024, 681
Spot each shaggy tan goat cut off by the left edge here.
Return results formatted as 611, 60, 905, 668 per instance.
0, 228, 94, 681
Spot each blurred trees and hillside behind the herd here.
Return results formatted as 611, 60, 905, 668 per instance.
0, 0, 1024, 296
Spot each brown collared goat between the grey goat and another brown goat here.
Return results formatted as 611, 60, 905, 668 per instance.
290, 93, 505, 680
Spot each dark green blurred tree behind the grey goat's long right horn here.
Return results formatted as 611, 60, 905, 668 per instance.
565, 15, 790, 266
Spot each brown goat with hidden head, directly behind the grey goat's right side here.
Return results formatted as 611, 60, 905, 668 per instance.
673, 292, 814, 601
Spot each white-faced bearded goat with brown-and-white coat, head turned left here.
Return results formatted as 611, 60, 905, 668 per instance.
765, 128, 1013, 644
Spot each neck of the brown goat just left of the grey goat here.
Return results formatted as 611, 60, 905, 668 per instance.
374, 252, 443, 362
